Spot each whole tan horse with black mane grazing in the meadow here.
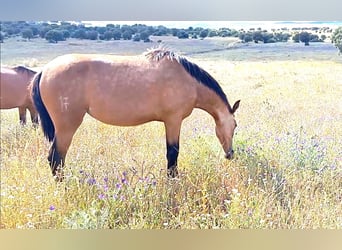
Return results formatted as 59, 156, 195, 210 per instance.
32, 49, 240, 179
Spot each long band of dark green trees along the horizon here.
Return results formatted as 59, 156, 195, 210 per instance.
0, 21, 338, 45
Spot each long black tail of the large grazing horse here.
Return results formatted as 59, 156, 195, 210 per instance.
31, 72, 55, 141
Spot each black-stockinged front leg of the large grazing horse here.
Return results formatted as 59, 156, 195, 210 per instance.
164, 120, 182, 178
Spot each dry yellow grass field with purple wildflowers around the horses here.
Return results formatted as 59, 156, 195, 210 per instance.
0, 39, 342, 229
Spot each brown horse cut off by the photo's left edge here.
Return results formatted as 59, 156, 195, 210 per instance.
0, 66, 38, 125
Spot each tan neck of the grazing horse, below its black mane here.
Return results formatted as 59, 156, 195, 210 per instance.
196, 84, 229, 122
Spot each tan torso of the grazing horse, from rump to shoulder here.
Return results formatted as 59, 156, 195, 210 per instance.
41, 55, 196, 125
